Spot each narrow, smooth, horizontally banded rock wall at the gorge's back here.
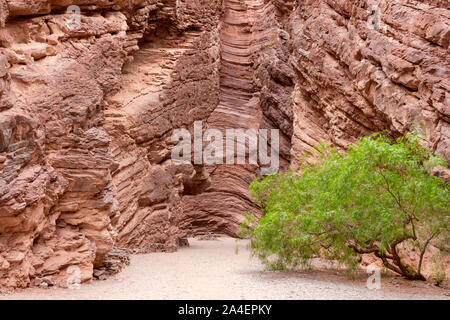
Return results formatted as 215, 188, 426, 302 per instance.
178, 0, 270, 236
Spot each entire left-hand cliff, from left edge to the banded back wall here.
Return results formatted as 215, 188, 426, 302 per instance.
0, 1, 220, 287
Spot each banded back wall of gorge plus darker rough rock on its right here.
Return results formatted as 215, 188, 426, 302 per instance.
180, 0, 294, 236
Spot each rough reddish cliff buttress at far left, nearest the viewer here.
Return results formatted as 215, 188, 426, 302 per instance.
0, 2, 134, 287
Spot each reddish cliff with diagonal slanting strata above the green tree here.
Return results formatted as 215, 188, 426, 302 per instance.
289, 0, 450, 165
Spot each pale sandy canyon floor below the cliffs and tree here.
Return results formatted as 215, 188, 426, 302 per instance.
0, 238, 450, 300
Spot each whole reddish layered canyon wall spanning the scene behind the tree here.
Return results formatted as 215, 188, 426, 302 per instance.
0, 0, 450, 288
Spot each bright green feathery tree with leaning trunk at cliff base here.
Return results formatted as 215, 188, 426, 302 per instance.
240, 133, 450, 280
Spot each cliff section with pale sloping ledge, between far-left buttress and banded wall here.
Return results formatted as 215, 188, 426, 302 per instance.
105, 2, 220, 252
